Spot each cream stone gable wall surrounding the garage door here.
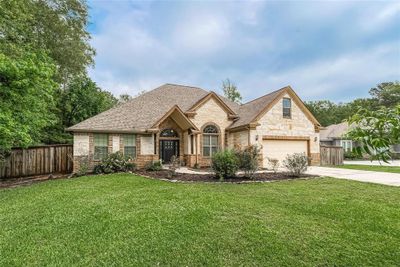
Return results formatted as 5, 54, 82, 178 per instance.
250, 95, 320, 165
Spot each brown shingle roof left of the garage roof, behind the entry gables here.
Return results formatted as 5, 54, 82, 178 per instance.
68, 84, 239, 132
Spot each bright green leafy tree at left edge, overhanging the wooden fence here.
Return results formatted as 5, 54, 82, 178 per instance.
0, 53, 57, 157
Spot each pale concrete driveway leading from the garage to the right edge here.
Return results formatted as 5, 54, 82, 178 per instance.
307, 166, 400, 186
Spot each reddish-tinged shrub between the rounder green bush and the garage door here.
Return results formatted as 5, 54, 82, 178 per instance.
235, 146, 260, 178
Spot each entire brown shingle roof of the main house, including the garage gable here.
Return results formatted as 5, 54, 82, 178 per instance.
67, 84, 319, 132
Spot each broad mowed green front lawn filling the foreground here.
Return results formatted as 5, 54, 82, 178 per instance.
0, 174, 400, 266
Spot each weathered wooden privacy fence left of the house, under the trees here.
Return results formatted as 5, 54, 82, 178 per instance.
0, 145, 72, 179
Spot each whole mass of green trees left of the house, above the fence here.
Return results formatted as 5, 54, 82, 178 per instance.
0, 0, 117, 155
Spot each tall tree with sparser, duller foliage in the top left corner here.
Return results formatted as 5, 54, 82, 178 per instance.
0, 0, 95, 84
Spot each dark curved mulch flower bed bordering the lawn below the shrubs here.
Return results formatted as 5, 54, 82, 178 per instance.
135, 170, 318, 183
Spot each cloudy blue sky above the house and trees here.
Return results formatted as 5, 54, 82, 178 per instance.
89, 0, 400, 102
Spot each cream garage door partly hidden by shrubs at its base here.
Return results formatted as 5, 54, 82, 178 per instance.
263, 140, 307, 168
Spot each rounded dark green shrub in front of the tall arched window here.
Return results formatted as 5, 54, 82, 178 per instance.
211, 149, 239, 180
